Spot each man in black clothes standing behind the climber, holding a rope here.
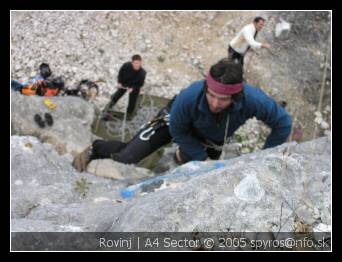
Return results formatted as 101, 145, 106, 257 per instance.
108, 55, 146, 118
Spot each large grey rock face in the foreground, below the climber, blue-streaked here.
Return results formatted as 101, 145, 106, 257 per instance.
11, 136, 331, 232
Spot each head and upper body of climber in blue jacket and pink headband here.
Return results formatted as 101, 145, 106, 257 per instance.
169, 59, 292, 163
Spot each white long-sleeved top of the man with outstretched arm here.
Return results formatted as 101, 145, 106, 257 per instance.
229, 24, 262, 55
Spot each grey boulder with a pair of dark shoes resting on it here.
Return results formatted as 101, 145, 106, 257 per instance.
11, 91, 95, 155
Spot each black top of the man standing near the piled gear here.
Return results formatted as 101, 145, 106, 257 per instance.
118, 62, 146, 88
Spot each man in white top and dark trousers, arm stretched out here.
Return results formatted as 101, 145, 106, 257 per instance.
228, 16, 271, 65
